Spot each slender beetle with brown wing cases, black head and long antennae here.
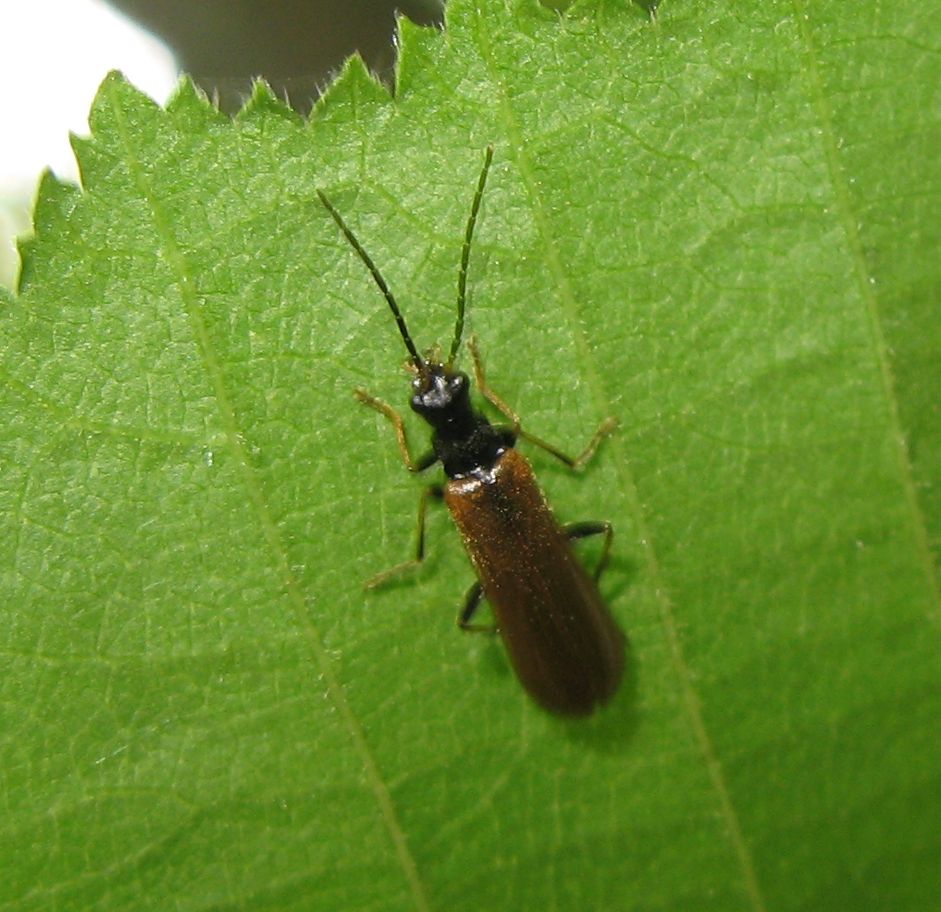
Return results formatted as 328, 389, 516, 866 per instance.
317, 147, 624, 716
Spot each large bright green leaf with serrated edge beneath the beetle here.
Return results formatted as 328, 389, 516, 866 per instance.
0, 0, 941, 912
